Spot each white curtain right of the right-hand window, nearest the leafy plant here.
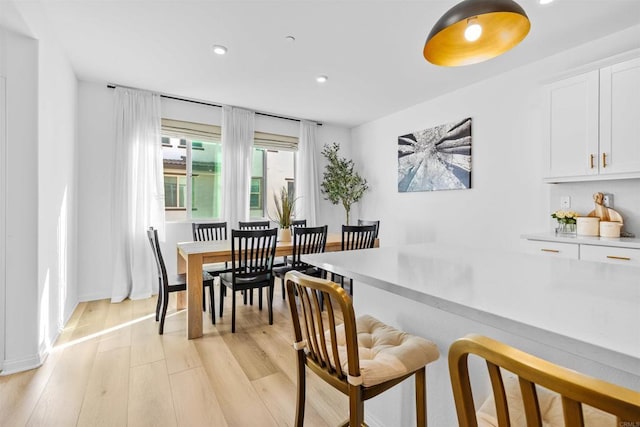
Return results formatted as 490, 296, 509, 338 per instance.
296, 120, 320, 227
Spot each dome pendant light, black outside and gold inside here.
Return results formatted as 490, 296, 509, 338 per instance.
423, 0, 531, 67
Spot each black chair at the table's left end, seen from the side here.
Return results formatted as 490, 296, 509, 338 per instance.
147, 227, 215, 335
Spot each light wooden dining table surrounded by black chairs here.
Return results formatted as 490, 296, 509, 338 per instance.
177, 233, 362, 339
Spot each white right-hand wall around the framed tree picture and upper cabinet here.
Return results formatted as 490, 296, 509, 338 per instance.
352, 26, 640, 250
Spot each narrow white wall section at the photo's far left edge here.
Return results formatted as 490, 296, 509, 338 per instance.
0, 28, 41, 373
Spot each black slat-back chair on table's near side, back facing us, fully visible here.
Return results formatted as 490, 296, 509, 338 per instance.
220, 228, 278, 332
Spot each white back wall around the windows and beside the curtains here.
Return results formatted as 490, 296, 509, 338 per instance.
78, 82, 350, 301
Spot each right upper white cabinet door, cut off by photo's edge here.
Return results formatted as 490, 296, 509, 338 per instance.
599, 59, 640, 174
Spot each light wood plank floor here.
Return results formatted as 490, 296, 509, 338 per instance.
0, 282, 348, 426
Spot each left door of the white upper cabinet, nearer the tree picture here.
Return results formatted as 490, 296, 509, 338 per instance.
547, 70, 599, 178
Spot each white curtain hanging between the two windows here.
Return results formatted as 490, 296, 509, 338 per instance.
222, 105, 255, 229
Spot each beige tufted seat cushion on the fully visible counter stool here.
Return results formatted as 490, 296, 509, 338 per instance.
325, 315, 440, 387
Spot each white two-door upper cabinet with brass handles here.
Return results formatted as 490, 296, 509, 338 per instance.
545, 58, 640, 182
